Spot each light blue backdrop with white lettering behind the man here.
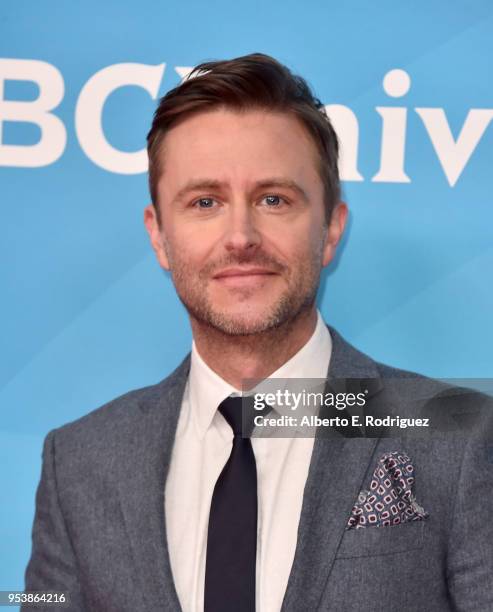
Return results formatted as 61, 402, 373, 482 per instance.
0, 0, 493, 589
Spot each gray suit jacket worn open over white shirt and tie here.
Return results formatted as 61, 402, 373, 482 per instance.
25, 329, 493, 612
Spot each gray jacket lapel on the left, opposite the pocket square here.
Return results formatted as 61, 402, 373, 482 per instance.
118, 357, 190, 612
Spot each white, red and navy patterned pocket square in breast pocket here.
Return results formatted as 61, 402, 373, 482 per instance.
346, 451, 428, 529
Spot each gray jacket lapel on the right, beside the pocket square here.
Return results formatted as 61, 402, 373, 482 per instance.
282, 328, 380, 612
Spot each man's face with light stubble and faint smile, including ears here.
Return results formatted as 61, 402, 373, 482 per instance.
145, 109, 347, 335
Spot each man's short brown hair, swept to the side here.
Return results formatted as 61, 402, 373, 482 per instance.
147, 53, 340, 222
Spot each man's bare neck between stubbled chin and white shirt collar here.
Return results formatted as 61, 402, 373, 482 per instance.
190, 307, 317, 389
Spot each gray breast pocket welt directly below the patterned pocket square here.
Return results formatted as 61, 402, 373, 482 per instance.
336, 519, 426, 559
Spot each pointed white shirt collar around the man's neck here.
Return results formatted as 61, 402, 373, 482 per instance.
188, 310, 332, 437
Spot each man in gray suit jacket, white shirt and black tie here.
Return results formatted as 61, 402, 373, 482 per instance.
26, 54, 493, 612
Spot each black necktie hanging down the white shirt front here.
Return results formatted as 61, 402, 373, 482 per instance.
204, 397, 257, 612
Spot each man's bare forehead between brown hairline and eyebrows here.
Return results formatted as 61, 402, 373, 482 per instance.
159, 109, 321, 195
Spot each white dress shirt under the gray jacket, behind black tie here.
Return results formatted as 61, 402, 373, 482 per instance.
165, 312, 332, 612
